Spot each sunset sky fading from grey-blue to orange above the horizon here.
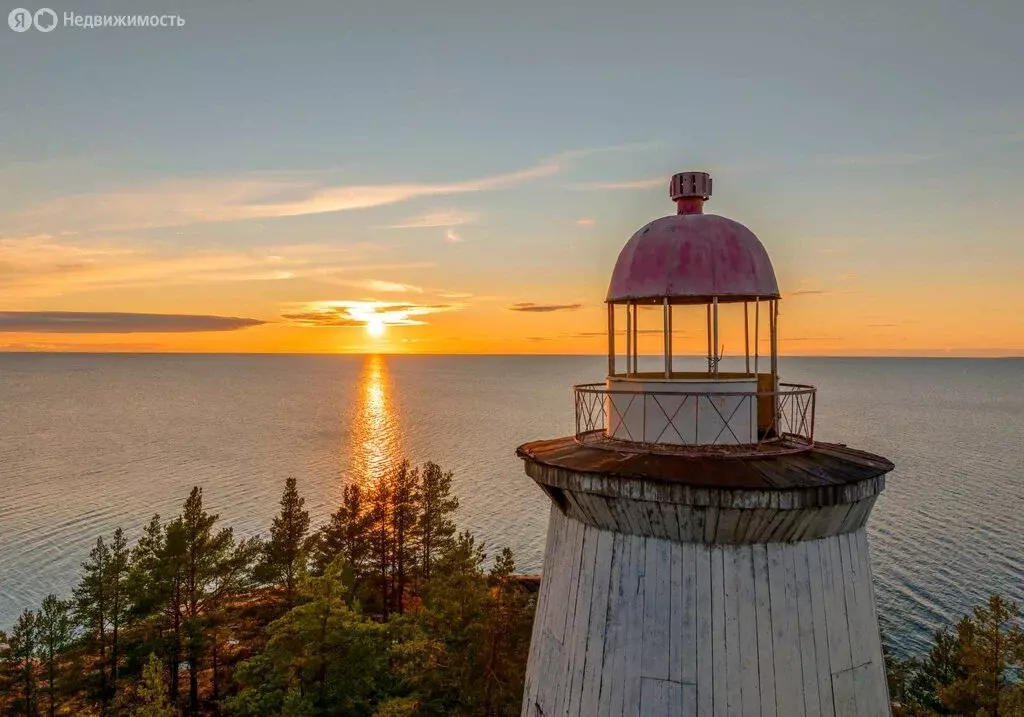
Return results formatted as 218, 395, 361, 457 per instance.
0, 0, 1024, 355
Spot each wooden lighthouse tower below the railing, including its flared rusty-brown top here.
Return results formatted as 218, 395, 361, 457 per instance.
518, 438, 892, 717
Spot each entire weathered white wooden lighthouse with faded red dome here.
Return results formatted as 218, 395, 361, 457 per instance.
516, 172, 893, 717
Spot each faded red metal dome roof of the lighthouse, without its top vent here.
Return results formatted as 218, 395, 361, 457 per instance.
607, 214, 779, 303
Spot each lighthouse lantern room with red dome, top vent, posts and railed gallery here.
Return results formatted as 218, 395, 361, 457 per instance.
575, 172, 814, 454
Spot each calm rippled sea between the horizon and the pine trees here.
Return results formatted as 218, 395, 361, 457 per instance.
0, 354, 1024, 650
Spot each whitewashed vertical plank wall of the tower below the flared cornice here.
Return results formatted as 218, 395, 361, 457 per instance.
522, 509, 890, 717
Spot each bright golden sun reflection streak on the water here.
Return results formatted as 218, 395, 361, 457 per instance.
350, 354, 401, 488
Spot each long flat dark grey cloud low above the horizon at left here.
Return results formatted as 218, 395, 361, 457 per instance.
0, 311, 265, 334
